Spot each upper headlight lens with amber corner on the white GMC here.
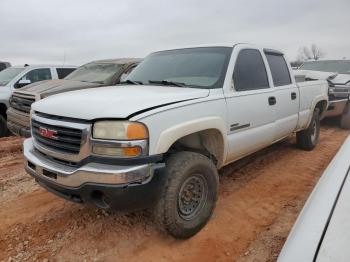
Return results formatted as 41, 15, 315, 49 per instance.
93, 120, 148, 140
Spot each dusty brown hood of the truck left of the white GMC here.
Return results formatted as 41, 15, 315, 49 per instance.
21, 79, 101, 98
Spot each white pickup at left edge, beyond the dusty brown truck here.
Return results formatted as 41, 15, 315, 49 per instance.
0, 65, 76, 137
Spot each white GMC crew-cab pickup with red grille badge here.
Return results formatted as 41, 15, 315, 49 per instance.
24, 44, 328, 238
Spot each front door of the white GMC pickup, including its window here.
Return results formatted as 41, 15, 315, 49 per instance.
226, 48, 276, 161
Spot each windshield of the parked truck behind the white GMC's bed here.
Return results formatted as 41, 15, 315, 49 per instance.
299, 60, 350, 75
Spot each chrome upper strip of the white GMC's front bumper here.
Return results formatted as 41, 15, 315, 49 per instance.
23, 138, 154, 187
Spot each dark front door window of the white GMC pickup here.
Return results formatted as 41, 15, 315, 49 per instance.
233, 49, 269, 91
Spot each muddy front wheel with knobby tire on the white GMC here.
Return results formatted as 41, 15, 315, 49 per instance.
155, 152, 219, 239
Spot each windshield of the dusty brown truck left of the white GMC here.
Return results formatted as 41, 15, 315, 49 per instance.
64, 63, 121, 84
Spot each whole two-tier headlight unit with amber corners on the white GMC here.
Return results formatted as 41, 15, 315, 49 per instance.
92, 120, 148, 157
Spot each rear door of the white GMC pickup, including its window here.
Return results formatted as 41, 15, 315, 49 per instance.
264, 50, 299, 141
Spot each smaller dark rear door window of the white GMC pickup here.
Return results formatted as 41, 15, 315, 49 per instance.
266, 53, 292, 86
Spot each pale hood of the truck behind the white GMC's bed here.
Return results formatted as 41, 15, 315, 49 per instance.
294, 70, 350, 85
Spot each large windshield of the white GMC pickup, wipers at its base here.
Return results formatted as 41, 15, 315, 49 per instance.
127, 47, 232, 88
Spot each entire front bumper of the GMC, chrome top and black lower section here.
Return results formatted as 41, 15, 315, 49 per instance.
23, 139, 164, 210
